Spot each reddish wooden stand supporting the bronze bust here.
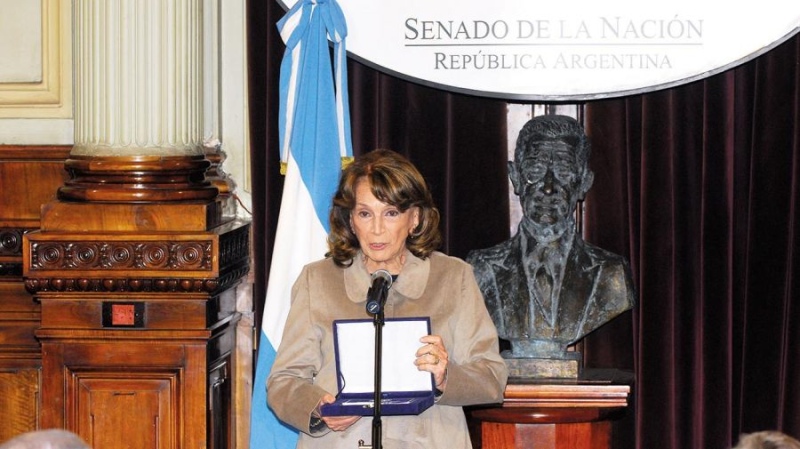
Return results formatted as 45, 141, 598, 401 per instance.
469, 376, 630, 449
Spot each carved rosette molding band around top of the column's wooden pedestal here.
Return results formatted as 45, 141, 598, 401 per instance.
24, 222, 250, 293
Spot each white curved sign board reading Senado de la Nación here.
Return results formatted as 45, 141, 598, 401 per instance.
278, 0, 800, 100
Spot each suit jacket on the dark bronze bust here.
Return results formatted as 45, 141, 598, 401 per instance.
467, 233, 636, 349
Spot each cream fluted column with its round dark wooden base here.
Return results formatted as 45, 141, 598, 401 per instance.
59, 0, 217, 202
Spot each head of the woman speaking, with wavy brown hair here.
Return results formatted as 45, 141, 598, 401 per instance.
328, 149, 442, 268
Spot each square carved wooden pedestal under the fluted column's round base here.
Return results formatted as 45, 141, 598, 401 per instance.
23, 202, 250, 449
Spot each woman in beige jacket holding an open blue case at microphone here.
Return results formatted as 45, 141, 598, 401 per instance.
267, 150, 508, 449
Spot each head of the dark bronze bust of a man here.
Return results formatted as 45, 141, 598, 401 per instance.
508, 115, 594, 240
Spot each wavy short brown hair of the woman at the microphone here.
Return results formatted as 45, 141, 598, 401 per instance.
326, 149, 442, 266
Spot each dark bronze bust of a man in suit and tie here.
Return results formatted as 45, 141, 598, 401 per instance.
467, 115, 635, 368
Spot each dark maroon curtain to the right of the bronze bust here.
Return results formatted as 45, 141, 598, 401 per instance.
585, 35, 800, 449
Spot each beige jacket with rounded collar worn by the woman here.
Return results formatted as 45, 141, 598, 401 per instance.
267, 252, 508, 449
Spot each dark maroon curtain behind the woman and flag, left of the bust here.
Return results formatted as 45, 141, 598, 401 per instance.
247, 0, 509, 358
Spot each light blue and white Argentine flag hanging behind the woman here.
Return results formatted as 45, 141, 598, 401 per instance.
250, 0, 353, 449
